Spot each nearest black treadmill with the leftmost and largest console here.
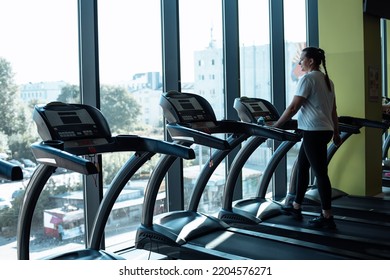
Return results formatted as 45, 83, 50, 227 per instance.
17, 102, 195, 260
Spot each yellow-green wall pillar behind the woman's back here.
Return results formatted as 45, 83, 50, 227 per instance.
318, 0, 382, 195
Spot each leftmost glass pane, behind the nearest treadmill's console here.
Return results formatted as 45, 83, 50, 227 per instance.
0, 0, 79, 259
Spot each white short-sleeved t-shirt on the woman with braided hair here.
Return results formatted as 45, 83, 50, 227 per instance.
295, 71, 335, 131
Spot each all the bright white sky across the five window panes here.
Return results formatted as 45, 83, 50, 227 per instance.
0, 0, 305, 84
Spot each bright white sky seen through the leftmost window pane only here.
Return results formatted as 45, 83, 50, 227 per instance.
0, 0, 78, 83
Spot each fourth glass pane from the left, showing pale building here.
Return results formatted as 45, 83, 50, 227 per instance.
238, 0, 272, 198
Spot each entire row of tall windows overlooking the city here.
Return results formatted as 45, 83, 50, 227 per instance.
0, 0, 306, 259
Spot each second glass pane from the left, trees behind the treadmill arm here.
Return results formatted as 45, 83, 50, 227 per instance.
98, 0, 165, 251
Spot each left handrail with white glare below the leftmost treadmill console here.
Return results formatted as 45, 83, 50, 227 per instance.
31, 142, 99, 175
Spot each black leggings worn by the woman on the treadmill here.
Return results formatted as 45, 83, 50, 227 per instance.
295, 131, 333, 210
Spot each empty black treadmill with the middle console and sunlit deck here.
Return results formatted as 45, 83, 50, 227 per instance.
136, 91, 351, 260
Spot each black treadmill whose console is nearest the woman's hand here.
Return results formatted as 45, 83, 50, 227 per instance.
219, 97, 390, 259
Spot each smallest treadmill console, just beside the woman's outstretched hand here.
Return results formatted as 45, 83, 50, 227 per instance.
234, 97, 280, 125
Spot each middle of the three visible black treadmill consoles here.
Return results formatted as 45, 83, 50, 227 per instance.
160, 91, 216, 123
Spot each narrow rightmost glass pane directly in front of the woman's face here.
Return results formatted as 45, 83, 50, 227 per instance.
284, 0, 306, 191
